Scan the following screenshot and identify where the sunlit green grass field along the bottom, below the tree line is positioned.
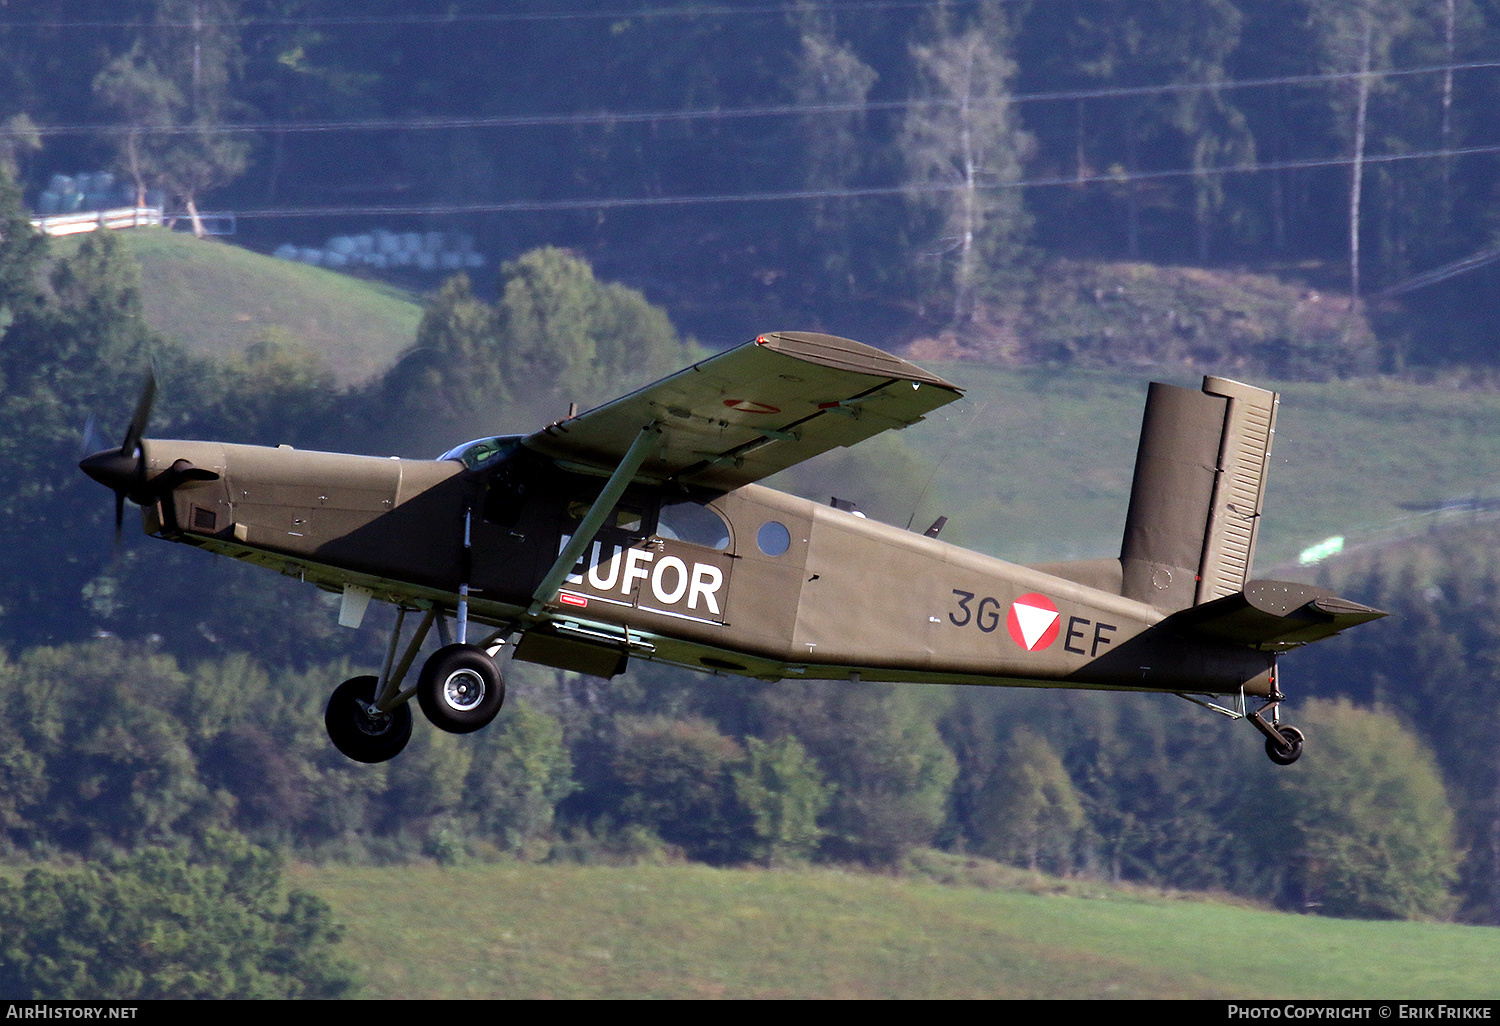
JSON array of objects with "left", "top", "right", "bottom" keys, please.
[{"left": 291, "top": 864, "right": 1500, "bottom": 999}]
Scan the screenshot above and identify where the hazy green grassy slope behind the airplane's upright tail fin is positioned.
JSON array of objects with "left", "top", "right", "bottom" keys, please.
[{"left": 780, "top": 360, "right": 1500, "bottom": 578}]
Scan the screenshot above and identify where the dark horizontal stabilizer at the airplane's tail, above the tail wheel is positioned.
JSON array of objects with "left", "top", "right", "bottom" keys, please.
[{"left": 1163, "top": 581, "right": 1386, "bottom": 651}]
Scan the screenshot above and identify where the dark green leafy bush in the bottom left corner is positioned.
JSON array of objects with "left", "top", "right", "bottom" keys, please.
[{"left": 0, "top": 834, "right": 356, "bottom": 1001}]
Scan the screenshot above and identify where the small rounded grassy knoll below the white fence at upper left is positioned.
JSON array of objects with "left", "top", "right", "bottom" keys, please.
[{"left": 53, "top": 228, "right": 422, "bottom": 384}]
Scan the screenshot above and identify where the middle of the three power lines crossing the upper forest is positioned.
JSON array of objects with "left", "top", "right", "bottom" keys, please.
[{"left": 20, "top": 60, "right": 1500, "bottom": 138}]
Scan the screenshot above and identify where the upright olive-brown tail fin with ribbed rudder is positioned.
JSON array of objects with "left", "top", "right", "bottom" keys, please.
[{"left": 1121, "top": 378, "right": 1278, "bottom": 611}]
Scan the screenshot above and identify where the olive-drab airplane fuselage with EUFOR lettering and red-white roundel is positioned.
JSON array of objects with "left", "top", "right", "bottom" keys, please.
[{"left": 144, "top": 440, "right": 1272, "bottom": 695}]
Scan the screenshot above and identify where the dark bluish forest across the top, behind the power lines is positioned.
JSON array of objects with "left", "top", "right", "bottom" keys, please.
[{"left": 0, "top": 0, "right": 1500, "bottom": 360}]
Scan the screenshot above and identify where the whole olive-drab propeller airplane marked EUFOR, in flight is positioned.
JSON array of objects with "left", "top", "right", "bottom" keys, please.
[{"left": 81, "top": 332, "right": 1383, "bottom": 764}]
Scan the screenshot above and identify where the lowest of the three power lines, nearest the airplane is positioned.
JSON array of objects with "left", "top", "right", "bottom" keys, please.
[{"left": 219, "top": 146, "right": 1500, "bottom": 221}]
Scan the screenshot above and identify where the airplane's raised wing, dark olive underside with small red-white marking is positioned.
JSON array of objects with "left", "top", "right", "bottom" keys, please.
[{"left": 524, "top": 332, "right": 963, "bottom": 491}]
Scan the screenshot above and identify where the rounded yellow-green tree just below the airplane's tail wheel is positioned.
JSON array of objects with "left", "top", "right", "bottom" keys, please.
[{"left": 1277, "top": 699, "right": 1460, "bottom": 920}]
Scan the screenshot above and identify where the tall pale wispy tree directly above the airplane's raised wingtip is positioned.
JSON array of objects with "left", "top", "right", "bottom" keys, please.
[{"left": 897, "top": 3, "right": 1031, "bottom": 324}]
